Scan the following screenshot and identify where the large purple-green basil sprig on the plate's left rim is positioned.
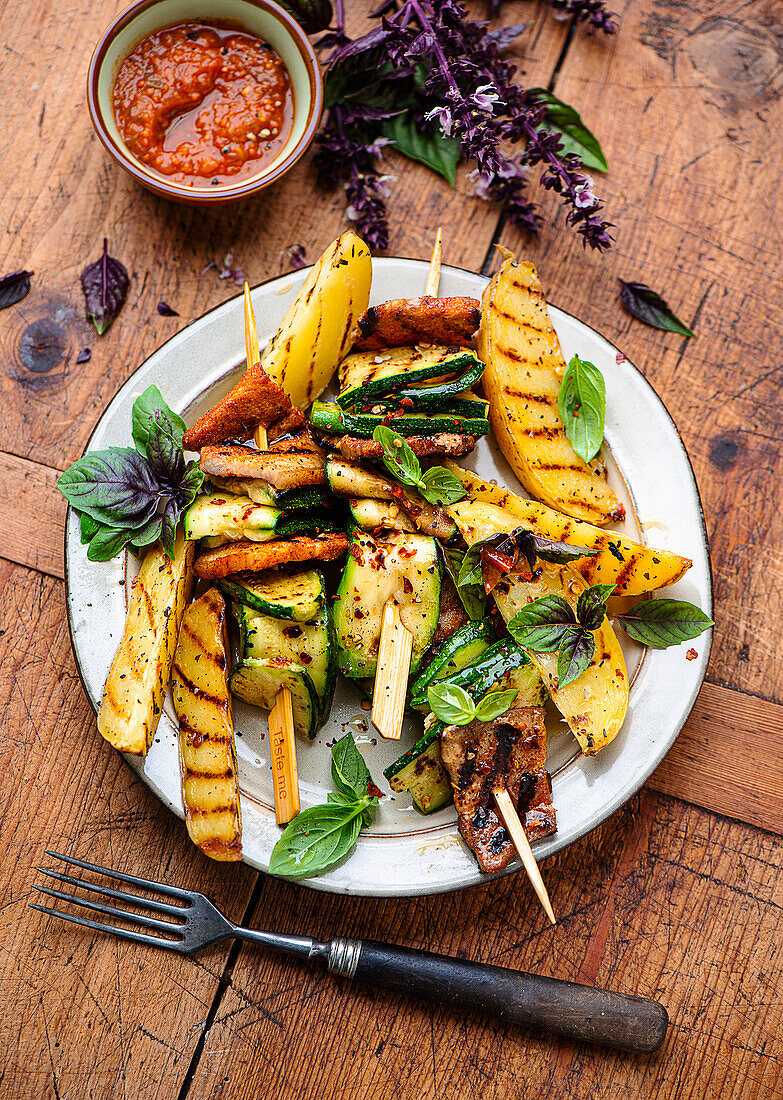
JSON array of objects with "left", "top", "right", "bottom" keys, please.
[{"left": 57, "top": 386, "right": 203, "bottom": 561}]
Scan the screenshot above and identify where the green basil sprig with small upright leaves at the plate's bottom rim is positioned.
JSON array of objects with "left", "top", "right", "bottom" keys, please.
[{"left": 269, "top": 734, "right": 378, "bottom": 878}]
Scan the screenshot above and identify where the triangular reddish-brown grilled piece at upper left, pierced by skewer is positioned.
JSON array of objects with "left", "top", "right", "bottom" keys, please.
[{"left": 183, "top": 363, "right": 304, "bottom": 451}]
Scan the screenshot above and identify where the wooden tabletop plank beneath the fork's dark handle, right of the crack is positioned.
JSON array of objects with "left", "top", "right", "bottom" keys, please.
[{"left": 188, "top": 793, "right": 783, "bottom": 1100}]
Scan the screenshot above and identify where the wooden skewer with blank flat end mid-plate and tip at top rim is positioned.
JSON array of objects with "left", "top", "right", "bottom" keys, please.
[{"left": 371, "top": 228, "right": 443, "bottom": 740}]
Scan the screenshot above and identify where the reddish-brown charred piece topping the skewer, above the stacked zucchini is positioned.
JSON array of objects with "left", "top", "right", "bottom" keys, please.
[{"left": 352, "top": 298, "right": 482, "bottom": 351}]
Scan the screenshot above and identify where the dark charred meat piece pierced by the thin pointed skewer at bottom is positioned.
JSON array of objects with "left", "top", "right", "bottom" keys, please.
[{"left": 440, "top": 706, "right": 556, "bottom": 873}]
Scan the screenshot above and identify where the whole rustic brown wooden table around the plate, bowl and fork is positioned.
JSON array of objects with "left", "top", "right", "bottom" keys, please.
[{"left": 0, "top": 0, "right": 783, "bottom": 1100}]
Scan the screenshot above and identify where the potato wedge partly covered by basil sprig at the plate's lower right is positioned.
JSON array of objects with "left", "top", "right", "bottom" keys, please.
[{"left": 493, "top": 562, "right": 628, "bottom": 756}]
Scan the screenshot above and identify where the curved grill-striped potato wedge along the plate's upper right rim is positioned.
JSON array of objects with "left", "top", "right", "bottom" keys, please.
[{"left": 478, "top": 254, "right": 622, "bottom": 527}]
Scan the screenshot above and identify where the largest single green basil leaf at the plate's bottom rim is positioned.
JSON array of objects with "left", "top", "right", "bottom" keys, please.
[{"left": 269, "top": 801, "right": 367, "bottom": 878}]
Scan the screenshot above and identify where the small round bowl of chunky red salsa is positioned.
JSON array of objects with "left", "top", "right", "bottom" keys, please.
[{"left": 88, "top": 0, "right": 322, "bottom": 204}]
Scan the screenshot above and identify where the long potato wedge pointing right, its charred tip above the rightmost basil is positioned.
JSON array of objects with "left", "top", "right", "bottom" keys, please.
[{"left": 443, "top": 470, "right": 692, "bottom": 596}]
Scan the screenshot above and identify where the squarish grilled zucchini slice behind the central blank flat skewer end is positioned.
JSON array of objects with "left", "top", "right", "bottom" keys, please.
[{"left": 332, "top": 529, "right": 441, "bottom": 679}]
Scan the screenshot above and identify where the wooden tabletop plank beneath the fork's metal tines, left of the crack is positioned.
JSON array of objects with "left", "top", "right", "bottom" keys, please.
[{"left": 0, "top": 562, "right": 256, "bottom": 1100}]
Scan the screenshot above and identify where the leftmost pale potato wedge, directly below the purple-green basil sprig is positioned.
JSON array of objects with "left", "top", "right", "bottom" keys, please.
[{"left": 98, "top": 531, "right": 196, "bottom": 756}]
